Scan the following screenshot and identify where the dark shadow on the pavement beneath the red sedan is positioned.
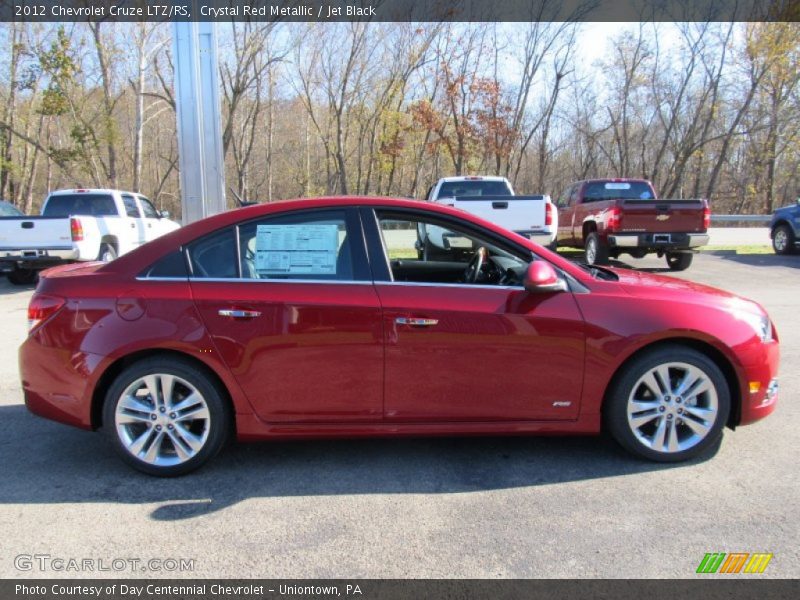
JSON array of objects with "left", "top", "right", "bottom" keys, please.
[{"left": 0, "top": 405, "right": 718, "bottom": 521}]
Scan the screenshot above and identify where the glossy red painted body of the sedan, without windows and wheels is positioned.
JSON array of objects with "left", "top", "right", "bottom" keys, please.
[{"left": 20, "top": 198, "right": 778, "bottom": 440}]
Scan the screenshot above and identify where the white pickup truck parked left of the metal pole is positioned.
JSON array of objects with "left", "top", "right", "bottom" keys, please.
[{"left": 0, "top": 189, "right": 180, "bottom": 285}]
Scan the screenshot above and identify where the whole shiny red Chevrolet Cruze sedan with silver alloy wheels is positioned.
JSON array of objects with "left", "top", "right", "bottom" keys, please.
[{"left": 20, "top": 198, "right": 778, "bottom": 475}]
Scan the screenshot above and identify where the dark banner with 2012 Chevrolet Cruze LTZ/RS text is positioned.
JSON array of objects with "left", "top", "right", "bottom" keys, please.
[{"left": 0, "top": 0, "right": 800, "bottom": 22}]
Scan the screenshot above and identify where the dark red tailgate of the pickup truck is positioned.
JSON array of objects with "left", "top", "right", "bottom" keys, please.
[{"left": 618, "top": 200, "right": 705, "bottom": 233}]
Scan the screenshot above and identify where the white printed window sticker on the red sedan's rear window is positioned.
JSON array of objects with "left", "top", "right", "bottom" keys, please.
[{"left": 256, "top": 224, "right": 339, "bottom": 276}]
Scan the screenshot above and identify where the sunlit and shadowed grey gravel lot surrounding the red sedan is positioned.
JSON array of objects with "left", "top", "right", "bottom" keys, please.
[{"left": 0, "top": 251, "right": 800, "bottom": 578}]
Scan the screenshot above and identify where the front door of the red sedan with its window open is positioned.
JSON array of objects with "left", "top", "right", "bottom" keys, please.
[{"left": 376, "top": 211, "right": 584, "bottom": 422}]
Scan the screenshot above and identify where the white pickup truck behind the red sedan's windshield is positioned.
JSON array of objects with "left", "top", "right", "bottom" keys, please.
[{"left": 418, "top": 176, "right": 558, "bottom": 257}]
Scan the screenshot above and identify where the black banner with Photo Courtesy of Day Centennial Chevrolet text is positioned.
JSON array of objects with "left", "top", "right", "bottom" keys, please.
[{"left": 0, "top": 576, "right": 800, "bottom": 600}]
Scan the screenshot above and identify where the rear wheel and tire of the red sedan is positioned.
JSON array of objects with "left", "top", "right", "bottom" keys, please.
[{"left": 103, "top": 357, "right": 232, "bottom": 477}]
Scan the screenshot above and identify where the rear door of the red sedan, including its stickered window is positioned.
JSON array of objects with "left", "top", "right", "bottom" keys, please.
[{"left": 188, "top": 209, "right": 383, "bottom": 423}]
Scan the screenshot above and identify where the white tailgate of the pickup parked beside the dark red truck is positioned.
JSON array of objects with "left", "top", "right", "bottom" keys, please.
[{"left": 444, "top": 196, "right": 547, "bottom": 231}]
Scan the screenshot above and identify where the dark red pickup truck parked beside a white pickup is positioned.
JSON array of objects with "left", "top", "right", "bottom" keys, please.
[{"left": 556, "top": 179, "right": 711, "bottom": 271}]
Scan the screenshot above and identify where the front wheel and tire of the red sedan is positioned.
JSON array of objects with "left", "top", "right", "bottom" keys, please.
[{"left": 603, "top": 345, "right": 731, "bottom": 462}]
